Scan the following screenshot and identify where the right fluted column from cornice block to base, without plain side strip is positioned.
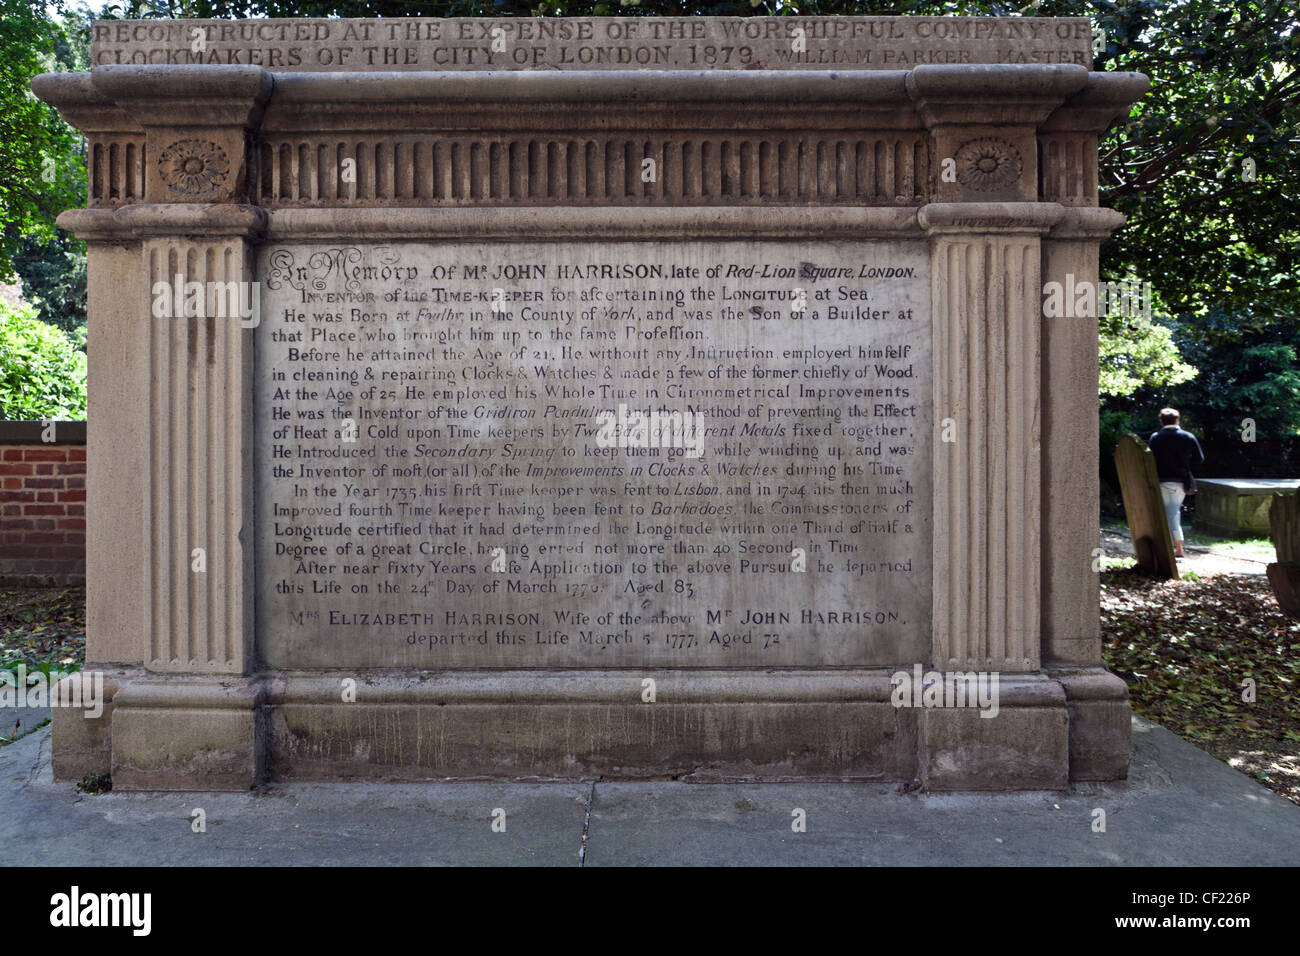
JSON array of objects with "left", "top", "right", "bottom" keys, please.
[{"left": 907, "top": 65, "right": 1089, "bottom": 788}]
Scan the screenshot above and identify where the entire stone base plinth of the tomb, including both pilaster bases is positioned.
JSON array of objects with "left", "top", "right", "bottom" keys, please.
[{"left": 53, "top": 669, "right": 1130, "bottom": 791}]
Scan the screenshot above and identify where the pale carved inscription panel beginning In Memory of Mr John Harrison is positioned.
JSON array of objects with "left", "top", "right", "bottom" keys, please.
[{"left": 255, "top": 241, "right": 932, "bottom": 670}]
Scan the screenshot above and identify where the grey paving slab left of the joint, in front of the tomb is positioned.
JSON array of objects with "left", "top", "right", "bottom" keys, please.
[{"left": 0, "top": 728, "right": 592, "bottom": 866}]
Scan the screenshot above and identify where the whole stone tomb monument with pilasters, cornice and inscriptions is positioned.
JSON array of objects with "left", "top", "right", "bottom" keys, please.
[{"left": 34, "top": 17, "right": 1147, "bottom": 790}]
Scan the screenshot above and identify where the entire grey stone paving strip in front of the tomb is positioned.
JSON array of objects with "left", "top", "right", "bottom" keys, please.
[{"left": 0, "top": 718, "right": 1300, "bottom": 866}]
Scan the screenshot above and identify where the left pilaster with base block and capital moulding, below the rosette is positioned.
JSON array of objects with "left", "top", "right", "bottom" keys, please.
[{"left": 56, "top": 203, "right": 267, "bottom": 790}]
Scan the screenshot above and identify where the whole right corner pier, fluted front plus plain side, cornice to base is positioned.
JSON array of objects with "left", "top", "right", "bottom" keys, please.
[{"left": 907, "top": 65, "right": 1145, "bottom": 787}]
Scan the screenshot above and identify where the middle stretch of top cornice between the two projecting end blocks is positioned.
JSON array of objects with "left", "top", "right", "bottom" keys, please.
[{"left": 264, "top": 70, "right": 922, "bottom": 138}]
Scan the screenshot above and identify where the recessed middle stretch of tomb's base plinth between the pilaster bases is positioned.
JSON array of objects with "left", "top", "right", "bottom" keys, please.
[{"left": 268, "top": 671, "right": 917, "bottom": 780}]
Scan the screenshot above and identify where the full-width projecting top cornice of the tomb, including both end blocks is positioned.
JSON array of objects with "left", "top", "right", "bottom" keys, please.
[{"left": 33, "top": 64, "right": 1148, "bottom": 133}]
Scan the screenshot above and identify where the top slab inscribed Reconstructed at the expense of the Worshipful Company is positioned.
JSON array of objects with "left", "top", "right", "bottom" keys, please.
[{"left": 91, "top": 17, "right": 1092, "bottom": 72}]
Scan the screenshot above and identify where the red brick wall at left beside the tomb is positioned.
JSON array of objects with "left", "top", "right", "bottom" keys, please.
[{"left": 0, "top": 421, "right": 86, "bottom": 585}]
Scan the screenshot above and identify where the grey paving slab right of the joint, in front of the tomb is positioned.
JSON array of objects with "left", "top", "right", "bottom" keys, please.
[{"left": 586, "top": 718, "right": 1300, "bottom": 866}]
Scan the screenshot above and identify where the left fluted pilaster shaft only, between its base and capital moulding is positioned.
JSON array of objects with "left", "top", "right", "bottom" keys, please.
[{"left": 143, "top": 238, "right": 254, "bottom": 674}]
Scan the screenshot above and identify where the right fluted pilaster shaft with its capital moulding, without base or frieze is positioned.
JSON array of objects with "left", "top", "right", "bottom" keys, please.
[{"left": 919, "top": 203, "right": 1061, "bottom": 671}]
